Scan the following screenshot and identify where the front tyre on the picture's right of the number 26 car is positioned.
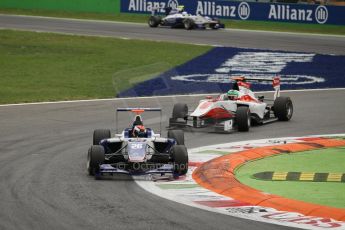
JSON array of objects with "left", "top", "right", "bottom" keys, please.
[{"left": 171, "top": 145, "right": 188, "bottom": 175}]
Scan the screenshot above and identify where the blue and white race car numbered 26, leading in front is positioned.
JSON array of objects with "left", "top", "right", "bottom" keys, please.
[{"left": 87, "top": 108, "right": 188, "bottom": 179}]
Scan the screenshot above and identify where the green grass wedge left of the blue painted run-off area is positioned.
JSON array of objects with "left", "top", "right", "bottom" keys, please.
[{"left": 0, "top": 30, "right": 211, "bottom": 104}]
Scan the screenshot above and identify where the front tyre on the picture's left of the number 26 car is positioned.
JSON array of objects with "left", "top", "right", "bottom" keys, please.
[{"left": 87, "top": 145, "right": 105, "bottom": 175}]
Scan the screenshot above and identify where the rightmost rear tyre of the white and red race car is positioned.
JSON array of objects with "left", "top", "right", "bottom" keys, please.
[{"left": 273, "top": 97, "right": 293, "bottom": 121}]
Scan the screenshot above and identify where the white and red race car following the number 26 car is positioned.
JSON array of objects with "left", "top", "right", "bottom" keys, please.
[{"left": 169, "top": 77, "right": 293, "bottom": 132}]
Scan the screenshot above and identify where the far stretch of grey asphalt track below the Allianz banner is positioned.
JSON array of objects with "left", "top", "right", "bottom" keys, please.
[{"left": 0, "top": 14, "right": 345, "bottom": 54}]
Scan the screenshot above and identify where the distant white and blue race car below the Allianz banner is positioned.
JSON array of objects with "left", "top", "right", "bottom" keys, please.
[{"left": 148, "top": 6, "right": 225, "bottom": 30}]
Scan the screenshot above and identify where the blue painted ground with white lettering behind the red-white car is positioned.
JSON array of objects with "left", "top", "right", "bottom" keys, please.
[{"left": 118, "top": 47, "right": 345, "bottom": 97}]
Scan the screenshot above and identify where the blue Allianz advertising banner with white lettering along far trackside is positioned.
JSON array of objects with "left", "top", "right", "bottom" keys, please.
[{"left": 121, "top": 0, "right": 345, "bottom": 25}]
